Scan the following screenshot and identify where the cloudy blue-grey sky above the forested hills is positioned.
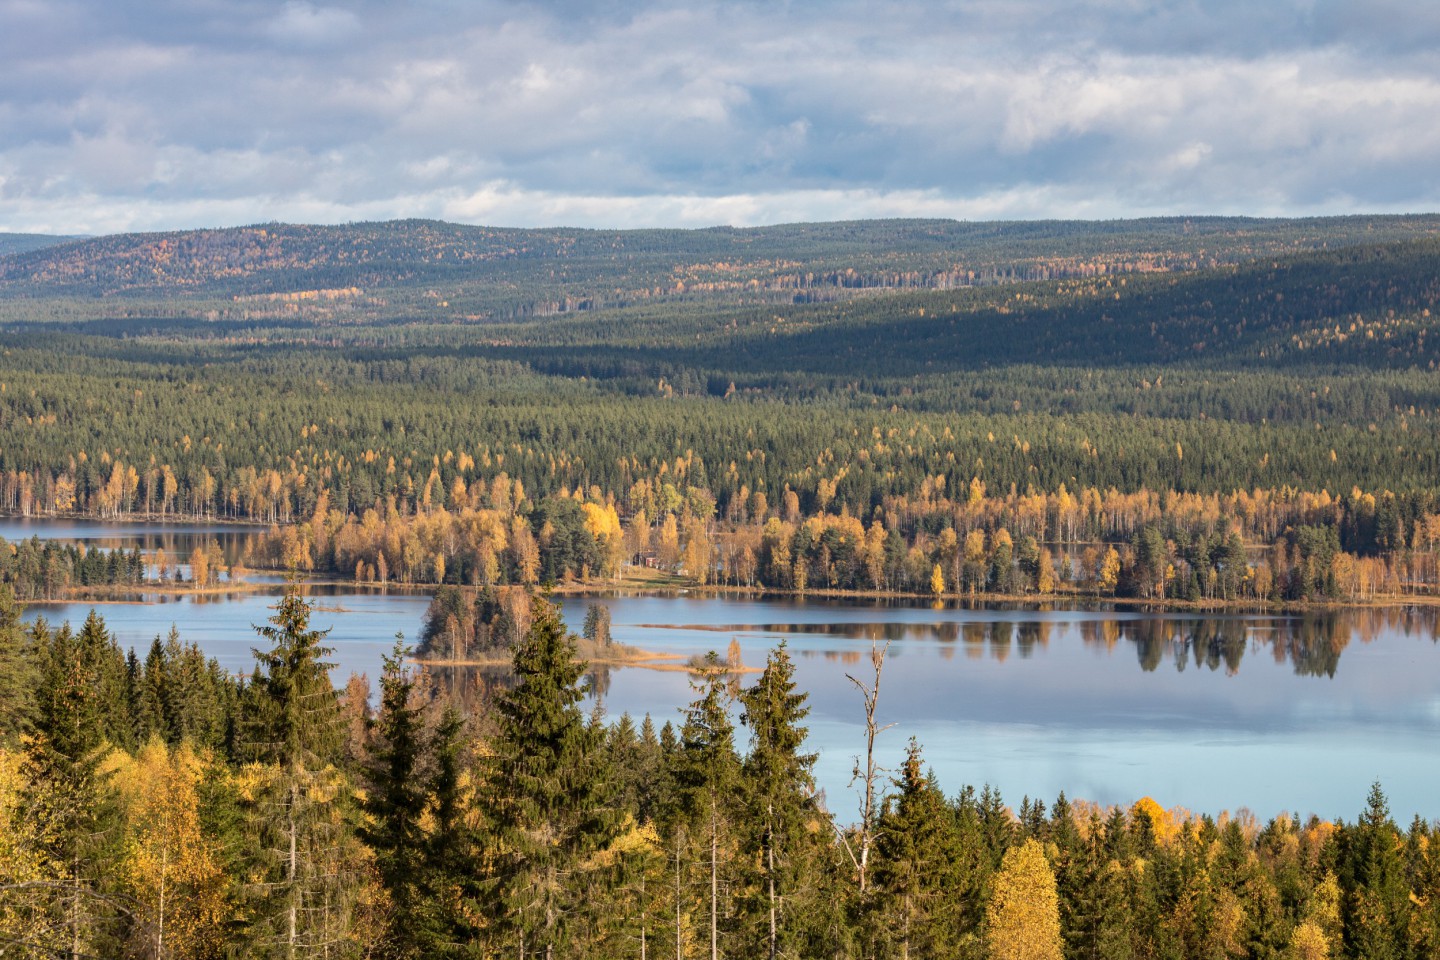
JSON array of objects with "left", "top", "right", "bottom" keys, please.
[{"left": 0, "top": 0, "right": 1440, "bottom": 235}]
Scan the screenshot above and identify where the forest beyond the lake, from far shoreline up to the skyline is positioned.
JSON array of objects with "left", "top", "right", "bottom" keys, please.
[{"left": 0, "top": 217, "right": 1440, "bottom": 602}]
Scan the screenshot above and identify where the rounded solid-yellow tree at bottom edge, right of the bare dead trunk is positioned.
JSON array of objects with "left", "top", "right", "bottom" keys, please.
[{"left": 985, "top": 841, "right": 1061, "bottom": 960}]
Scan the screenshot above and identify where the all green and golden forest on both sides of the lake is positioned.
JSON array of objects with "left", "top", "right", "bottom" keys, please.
[{"left": 0, "top": 217, "right": 1440, "bottom": 960}]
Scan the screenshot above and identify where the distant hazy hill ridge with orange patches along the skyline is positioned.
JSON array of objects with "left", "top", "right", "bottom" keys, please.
[{"left": 8, "top": 216, "right": 1440, "bottom": 303}]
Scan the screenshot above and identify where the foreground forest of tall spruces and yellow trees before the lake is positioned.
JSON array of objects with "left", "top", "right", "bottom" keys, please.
[{"left": 0, "top": 589, "right": 1440, "bottom": 960}]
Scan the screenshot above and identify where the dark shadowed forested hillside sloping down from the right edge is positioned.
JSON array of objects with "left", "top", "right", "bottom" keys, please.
[{"left": 457, "top": 239, "right": 1440, "bottom": 386}]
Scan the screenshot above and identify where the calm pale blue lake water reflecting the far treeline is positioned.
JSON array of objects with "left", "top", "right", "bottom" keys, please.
[{"left": 11, "top": 522, "right": 1440, "bottom": 820}]
